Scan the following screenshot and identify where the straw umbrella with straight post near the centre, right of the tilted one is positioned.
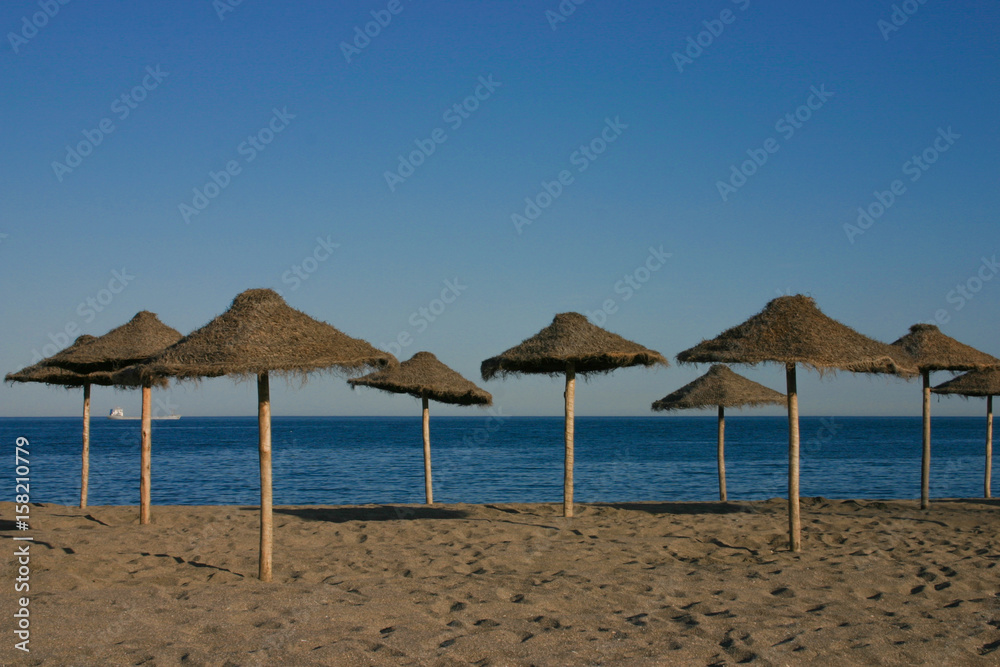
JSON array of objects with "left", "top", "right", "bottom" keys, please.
[{"left": 480, "top": 313, "right": 669, "bottom": 517}]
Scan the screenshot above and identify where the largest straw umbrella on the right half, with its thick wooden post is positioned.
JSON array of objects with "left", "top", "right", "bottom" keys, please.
[{"left": 677, "top": 294, "right": 914, "bottom": 551}]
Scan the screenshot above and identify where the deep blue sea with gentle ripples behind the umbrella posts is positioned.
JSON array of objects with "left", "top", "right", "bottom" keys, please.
[{"left": 0, "top": 413, "right": 1000, "bottom": 505}]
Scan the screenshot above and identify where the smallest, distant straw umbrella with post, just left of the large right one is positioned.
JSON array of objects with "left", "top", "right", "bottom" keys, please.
[{"left": 652, "top": 364, "right": 785, "bottom": 502}]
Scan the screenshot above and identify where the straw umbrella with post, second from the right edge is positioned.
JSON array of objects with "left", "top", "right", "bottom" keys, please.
[{"left": 893, "top": 324, "right": 1000, "bottom": 509}]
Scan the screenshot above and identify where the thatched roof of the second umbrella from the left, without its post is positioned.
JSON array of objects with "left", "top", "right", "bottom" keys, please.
[{"left": 44, "top": 310, "right": 181, "bottom": 373}]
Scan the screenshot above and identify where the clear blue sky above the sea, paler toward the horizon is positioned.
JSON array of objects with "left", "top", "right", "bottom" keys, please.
[{"left": 0, "top": 0, "right": 1000, "bottom": 416}]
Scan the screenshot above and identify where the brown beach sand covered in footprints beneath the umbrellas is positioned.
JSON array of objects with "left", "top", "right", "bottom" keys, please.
[{"left": 0, "top": 498, "right": 1000, "bottom": 665}]
